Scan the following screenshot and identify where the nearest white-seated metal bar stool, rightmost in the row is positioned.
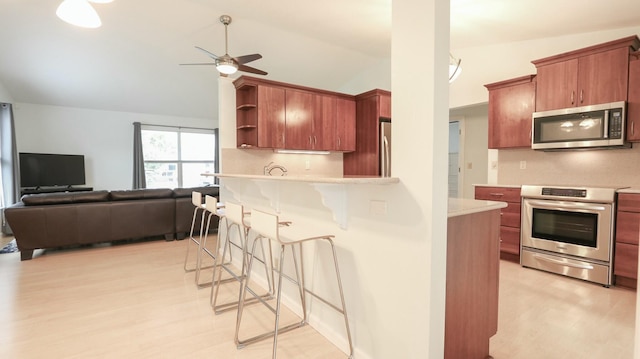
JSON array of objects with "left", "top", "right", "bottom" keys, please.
[{"left": 235, "top": 210, "right": 353, "bottom": 359}]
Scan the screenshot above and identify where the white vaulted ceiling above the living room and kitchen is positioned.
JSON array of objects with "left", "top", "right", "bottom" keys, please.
[{"left": 0, "top": 0, "right": 640, "bottom": 118}]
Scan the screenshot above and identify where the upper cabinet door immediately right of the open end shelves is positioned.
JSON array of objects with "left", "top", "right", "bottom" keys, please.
[{"left": 258, "top": 85, "right": 285, "bottom": 148}]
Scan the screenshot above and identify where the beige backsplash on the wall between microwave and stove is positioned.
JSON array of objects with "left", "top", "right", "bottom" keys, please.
[{"left": 498, "top": 144, "right": 640, "bottom": 187}]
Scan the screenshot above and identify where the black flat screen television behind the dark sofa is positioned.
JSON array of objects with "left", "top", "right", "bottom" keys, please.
[{"left": 19, "top": 152, "right": 85, "bottom": 187}]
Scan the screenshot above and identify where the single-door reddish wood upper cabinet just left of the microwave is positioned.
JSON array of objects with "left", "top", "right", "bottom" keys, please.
[{"left": 485, "top": 75, "right": 536, "bottom": 149}]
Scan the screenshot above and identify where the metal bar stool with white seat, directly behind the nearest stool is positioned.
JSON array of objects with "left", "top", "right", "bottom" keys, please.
[{"left": 207, "top": 202, "right": 273, "bottom": 314}]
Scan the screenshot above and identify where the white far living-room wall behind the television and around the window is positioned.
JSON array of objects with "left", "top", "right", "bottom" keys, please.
[{"left": 13, "top": 103, "right": 217, "bottom": 190}]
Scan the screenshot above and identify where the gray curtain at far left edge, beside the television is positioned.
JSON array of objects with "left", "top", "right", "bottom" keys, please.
[{"left": 0, "top": 103, "right": 20, "bottom": 234}]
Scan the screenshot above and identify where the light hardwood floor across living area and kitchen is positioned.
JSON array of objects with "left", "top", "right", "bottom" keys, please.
[{"left": 0, "top": 240, "right": 635, "bottom": 359}]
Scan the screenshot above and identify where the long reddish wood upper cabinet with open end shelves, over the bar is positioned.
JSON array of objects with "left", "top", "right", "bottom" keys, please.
[{"left": 234, "top": 76, "right": 356, "bottom": 152}]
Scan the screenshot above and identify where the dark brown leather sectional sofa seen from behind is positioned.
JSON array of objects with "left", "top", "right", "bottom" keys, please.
[{"left": 4, "top": 186, "right": 219, "bottom": 260}]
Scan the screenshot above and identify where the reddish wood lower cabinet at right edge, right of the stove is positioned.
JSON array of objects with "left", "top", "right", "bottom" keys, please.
[{"left": 613, "top": 193, "right": 640, "bottom": 288}]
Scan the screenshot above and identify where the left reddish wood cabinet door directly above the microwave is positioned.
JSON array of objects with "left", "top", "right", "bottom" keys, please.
[{"left": 536, "top": 59, "right": 578, "bottom": 111}]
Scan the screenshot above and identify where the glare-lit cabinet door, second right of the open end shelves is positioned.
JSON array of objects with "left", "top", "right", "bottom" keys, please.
[{"left": 285, "top": 89, "right": 314, "bottom": 150}]
